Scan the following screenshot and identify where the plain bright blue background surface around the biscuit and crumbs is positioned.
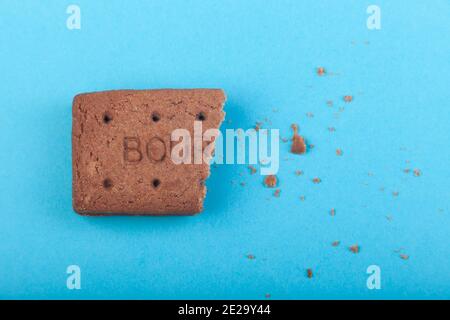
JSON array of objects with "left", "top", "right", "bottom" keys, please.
[{"left": 0, "top": 0, "right": 450, "bottom": 299}]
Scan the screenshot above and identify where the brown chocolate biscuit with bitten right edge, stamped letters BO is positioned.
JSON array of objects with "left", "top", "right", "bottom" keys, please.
[{"left": 72, "top": 89, "right": 225, "bottom": 215}]
